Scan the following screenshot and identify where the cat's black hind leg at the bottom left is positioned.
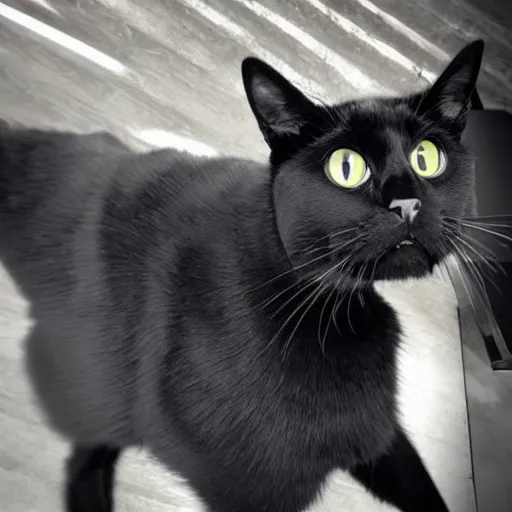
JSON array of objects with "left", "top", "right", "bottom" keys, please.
[{"left": 64, "top": 445, "right": 121, "bottom": 512}]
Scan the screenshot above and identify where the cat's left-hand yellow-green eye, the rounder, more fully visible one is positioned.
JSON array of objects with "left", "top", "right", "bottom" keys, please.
[{"left": 326, "top": 149, "right": 370, "bottom": 188}]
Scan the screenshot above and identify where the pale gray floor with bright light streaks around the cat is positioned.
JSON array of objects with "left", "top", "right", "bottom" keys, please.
[{"left": 0, "top": 0, "right": 512, "bottom": 512}]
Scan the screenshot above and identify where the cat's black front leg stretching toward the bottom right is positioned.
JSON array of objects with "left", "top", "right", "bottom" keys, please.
[{"left": 350, "top": 430, "right": 449, "bottom": 512}]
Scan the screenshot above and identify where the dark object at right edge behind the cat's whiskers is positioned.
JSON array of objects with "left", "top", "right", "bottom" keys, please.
[{"left": 459, "top": 110, "right": 512, "bottom": 371}]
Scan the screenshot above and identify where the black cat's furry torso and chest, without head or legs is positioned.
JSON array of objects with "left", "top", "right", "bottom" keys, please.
[{"left": 0, "top": 125, "right": 398, "bottom": 510}]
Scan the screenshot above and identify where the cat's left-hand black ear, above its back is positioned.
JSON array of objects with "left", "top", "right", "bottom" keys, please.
[{"left": 242, "top": 57, "right": 317, "bottom": 149}]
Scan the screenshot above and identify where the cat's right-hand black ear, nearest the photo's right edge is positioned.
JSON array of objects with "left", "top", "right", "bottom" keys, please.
[{"left": 419, "top": 40, "right": 484, "bottom": 131}]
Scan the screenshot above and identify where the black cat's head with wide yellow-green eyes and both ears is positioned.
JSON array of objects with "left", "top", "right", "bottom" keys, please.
[{"left": 242, "top": 41, "right": 484, "bottom": 283}]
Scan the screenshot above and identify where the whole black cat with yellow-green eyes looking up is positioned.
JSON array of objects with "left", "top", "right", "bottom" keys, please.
[{"left": 0, "top": 41, "right": 483, "bottom": 512}]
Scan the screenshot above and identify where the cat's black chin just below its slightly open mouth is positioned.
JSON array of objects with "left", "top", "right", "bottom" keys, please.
[{"left": 374, "top": 245, "right": 435, "bottom": 281}]
